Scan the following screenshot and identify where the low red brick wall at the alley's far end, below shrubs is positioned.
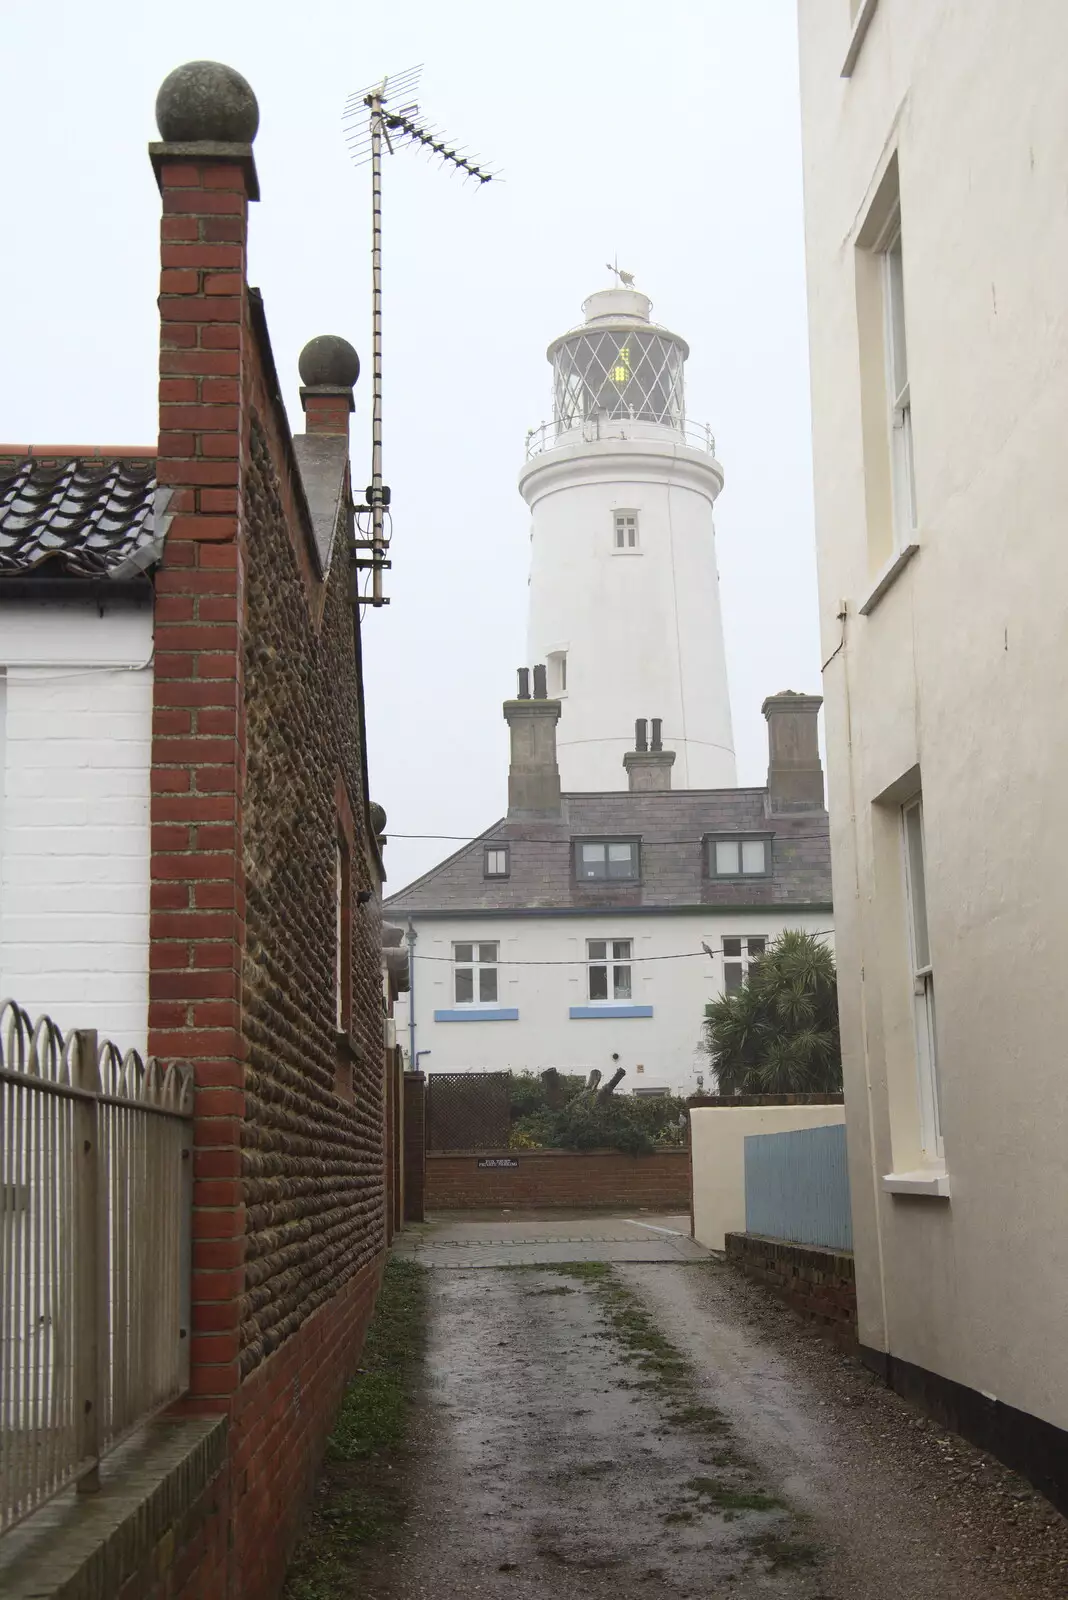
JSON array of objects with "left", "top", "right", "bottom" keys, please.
[{"left": 427, "top": 1150, "right": 689, "bottom": 1211}]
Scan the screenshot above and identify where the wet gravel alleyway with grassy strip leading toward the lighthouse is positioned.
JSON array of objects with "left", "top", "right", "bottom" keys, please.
[{"left": 321, "top": 1218, "right": 1068, "bottom": 1600}]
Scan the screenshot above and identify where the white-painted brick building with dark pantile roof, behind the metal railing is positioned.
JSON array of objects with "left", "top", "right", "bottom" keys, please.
[{"left": 0, "top": 450, "right": 166, "bottom": 1051}]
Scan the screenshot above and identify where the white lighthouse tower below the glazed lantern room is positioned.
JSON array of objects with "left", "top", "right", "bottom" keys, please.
[{"left": 523, "top": 440, "right": 737, "bottom": 790}]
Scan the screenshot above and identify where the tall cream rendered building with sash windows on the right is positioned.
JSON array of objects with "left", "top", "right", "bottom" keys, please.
[{"left": 799, "top": 0, "right": 1068, "bottom": 1507}]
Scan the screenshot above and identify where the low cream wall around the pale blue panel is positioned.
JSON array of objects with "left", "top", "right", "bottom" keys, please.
[{"left": 689, "top": 1106, "right": 846, "bottom": 1250}]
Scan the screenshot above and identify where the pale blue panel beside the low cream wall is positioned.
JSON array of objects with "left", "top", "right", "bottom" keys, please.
[{"left": 745, "top": 1123, "right": 852, "bottom": 1250}]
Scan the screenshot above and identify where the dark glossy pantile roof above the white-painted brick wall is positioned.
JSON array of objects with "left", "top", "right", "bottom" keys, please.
[{"left": 0, "top": 451, "right": 158, "bottom": 579}]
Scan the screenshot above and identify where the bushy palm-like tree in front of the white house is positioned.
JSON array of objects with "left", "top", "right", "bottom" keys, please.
[{"left": 703, "top": 928, "right": 843, "bottom": 1094}]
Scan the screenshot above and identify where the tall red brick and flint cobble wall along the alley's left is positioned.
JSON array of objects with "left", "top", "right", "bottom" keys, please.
[{"left": 143, "top": 118, "right": 385, "bottom": 1600}]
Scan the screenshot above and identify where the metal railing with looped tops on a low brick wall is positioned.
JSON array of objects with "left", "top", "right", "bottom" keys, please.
[{"left": 0, "top": 1000, "right": 193, "bottom": 1533}]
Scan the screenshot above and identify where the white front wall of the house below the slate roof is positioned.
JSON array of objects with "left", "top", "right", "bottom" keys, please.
[{"left": 397, "top": 907, "right": 830, "bottom": 1094}]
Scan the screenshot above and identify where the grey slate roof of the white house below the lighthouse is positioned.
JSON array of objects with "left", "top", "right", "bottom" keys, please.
[{"left": 384, "top": 789, "right": 831, "bottom": 917}]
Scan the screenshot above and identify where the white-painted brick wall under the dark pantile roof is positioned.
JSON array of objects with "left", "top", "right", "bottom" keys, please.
[{"left": 0, "top": 602, "right": 152, "bottom": 1050}]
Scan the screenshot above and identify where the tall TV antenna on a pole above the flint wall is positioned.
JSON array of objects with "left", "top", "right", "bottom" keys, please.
[{"left": 344, "top": 66, "right": 497, "bottom": 606}]
